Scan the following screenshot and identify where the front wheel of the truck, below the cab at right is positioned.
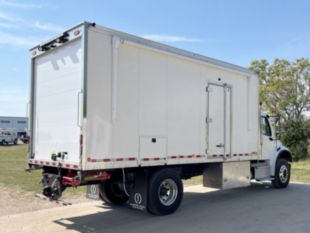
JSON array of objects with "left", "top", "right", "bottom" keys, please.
[{"left": 272, "top": 159, "right": 291, "bottom": 188}]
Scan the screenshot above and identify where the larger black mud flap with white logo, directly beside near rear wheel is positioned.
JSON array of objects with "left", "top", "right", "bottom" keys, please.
[{"left": 128, "top": 171, "right": 148, "bottom": 211}]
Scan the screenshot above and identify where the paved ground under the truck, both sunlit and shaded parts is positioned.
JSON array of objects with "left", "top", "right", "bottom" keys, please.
[{"left": 0, "top": 184, "right": 310, "bottom": 233}]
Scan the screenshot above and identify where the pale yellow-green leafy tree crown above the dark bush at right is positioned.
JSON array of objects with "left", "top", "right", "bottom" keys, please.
[{"left": 250, "top": 58, "right": 310, "bottom": 120}]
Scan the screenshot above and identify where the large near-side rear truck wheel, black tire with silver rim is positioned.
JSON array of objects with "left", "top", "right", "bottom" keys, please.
[{"left": 147, "top": 169, "right": 183, "bottom": 215}]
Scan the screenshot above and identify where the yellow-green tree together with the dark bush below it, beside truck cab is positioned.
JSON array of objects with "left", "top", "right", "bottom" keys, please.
[{"left": 250, "top": 58, "right": 310, "bottom": 160}]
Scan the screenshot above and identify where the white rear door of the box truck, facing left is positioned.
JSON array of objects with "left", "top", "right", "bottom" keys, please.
[{"left": 32, "top": 37, "right": 83, "bottom": 164}]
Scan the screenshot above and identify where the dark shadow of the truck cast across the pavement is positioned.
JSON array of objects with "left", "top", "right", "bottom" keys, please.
[{"left": 55, "top": 184, "right": 310, "bottom": 233}]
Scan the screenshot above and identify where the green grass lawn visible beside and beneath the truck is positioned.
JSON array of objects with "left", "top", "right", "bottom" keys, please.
[{"left": 0, "top": 145, "right": 310, "bottom": 195}]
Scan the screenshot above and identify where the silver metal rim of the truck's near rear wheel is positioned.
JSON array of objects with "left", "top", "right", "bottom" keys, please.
[{"left": 158, "top": 179, "right": 178, "bottom": 206}]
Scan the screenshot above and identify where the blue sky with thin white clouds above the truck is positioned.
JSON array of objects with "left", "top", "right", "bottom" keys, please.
[{"left": 0, "top": 0, "right": 310, "bottom": 116}]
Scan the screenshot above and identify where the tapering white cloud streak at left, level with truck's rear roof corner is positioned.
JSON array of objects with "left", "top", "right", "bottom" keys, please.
[{"left": 0, "top": 32, "right": 46, "bottom": 48}]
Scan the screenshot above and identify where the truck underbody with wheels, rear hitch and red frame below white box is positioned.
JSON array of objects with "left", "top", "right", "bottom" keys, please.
[{"left": 32, "top": 154, "right": 291, "bottom": 215}]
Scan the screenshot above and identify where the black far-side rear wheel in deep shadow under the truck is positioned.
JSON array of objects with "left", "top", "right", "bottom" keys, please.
[{"left": 99, "top": 180, "right": 129, "bottom": 205}]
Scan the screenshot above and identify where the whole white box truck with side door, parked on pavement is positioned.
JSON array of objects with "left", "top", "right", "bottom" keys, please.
[{"left": 28, "top": 22, "right": 292, "bottom": 215}]
